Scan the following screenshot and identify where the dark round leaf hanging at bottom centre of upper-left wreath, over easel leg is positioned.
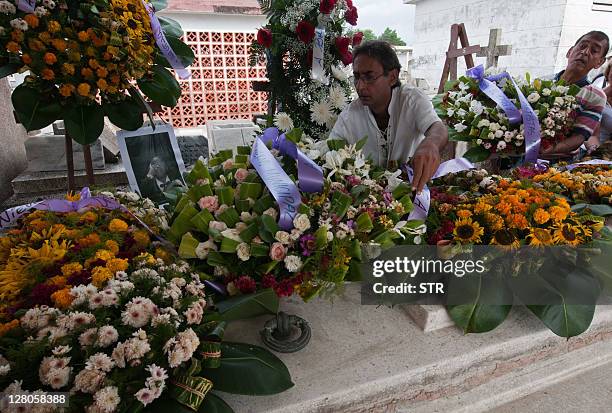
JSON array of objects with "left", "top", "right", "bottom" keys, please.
[{"left": 64, "top": 103, "right": 104, "bottom": 145}]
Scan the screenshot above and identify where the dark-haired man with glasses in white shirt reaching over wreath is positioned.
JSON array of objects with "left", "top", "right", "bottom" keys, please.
[{"left": 330, "top": 40, "right": 448, "bottom": 192}]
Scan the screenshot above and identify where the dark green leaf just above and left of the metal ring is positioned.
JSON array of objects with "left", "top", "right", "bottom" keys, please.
[{"left": 214, "top": 288, "right": 278, "bottom": 321}]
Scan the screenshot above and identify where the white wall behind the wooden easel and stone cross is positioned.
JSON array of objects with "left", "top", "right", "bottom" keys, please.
[{"left": 405, "top": 0, "right": 568, "bottom": 89}]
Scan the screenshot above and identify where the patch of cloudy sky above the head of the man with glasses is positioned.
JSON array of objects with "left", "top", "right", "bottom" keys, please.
[{"left": 353, "top": 0, "right": 415, "bottom": 46}]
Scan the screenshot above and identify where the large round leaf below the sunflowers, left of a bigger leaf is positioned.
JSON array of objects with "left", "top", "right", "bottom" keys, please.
[{"left": 447, "top": 275, "right": 512, "bottom": 333}]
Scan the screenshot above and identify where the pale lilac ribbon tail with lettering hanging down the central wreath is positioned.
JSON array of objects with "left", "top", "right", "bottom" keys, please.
[{"left": 251, "top": 138, "right": 302, "bottom": 231}]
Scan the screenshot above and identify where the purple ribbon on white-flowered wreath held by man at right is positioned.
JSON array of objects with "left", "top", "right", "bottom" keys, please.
[{"left": 466, "top": 65, "right": 541, "bottom": 163}]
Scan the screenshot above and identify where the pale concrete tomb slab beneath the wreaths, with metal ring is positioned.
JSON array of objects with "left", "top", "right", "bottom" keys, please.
[{"left": 224, "top": 285, "right": 612, "bottom": 413}]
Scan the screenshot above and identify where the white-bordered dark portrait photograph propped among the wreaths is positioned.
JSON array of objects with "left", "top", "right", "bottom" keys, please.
[{"left": 117, "top": 125, "right": 185, "bottom": 204}]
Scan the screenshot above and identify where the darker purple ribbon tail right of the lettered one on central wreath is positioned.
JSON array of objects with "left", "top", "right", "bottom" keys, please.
[{"left": 259, "top": 128, "right": 323, "bottom": 193}]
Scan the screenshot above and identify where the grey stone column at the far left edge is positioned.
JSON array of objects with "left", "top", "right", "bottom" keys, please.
[{"left": 0, "top": 78, "right": 28, "bottom": 204}]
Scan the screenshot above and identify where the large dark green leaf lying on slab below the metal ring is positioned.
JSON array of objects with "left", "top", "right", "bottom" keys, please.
[{"left": 202, "top": 343, "right": 293, "bottom": 395}]
